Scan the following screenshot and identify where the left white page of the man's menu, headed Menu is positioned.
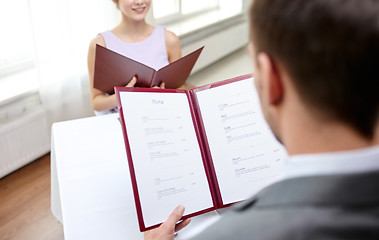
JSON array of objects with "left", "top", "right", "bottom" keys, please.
[{"left": 120, "top": 92, "right": 213, "bottom": 227}]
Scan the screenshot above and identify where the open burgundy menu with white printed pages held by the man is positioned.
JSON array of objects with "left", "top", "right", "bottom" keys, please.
[{"left": 115, "top": 75, "right": 286, "bottom": 231}]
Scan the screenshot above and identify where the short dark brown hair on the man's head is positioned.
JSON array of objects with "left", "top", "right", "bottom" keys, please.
[{"left": 250, "top": 0, "right": 379, "bottom": 138}]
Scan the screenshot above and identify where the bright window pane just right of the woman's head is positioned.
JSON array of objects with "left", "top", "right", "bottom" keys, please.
[{"left": 153, "top": 0, "right": 220, "bottom": 23}]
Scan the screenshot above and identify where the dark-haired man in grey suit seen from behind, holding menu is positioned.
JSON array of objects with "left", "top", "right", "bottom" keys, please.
[{"left": 145, "top": 0, "right": 379, "bottom": 240}]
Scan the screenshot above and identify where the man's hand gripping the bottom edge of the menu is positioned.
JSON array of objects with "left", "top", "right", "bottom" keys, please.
[{"left": 144, "top": 205, "right": 191, "bottom": 240}]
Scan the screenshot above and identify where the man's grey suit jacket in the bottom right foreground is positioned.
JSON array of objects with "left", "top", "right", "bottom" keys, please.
[{"left": 194, "top": 170, "right": 379, "bottom": 240}]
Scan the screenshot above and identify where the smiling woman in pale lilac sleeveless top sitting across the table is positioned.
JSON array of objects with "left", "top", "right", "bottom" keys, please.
[{"left": 88, "top": 0, "right": 181, "bottom": 113}]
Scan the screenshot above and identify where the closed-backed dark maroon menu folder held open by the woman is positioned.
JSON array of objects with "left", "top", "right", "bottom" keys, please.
[{"left": 94, "top": 45, "right": 204, "bottom": 94}]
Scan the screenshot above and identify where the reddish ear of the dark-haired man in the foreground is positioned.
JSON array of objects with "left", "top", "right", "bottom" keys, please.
[{"left": 257, "top": 53, "right": 284, "bottom": 105}]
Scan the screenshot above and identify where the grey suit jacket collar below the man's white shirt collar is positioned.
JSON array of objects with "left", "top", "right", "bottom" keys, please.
[{"left": 235, "top": 170, "right": 379, "bottom": 211}]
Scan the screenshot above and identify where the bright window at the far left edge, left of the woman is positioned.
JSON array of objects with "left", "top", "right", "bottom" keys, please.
[{"left": 0, "top": 0, "right": 38, "bottom": 102}]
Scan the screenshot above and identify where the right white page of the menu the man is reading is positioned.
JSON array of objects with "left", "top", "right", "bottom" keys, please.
[{"left": 196, "top": 78, "right": 286, "bottom": 204}]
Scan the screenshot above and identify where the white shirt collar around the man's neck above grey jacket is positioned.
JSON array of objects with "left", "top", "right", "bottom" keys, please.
[{"left": 283, "top": 146, "right": 379, "bottom": 179}]
